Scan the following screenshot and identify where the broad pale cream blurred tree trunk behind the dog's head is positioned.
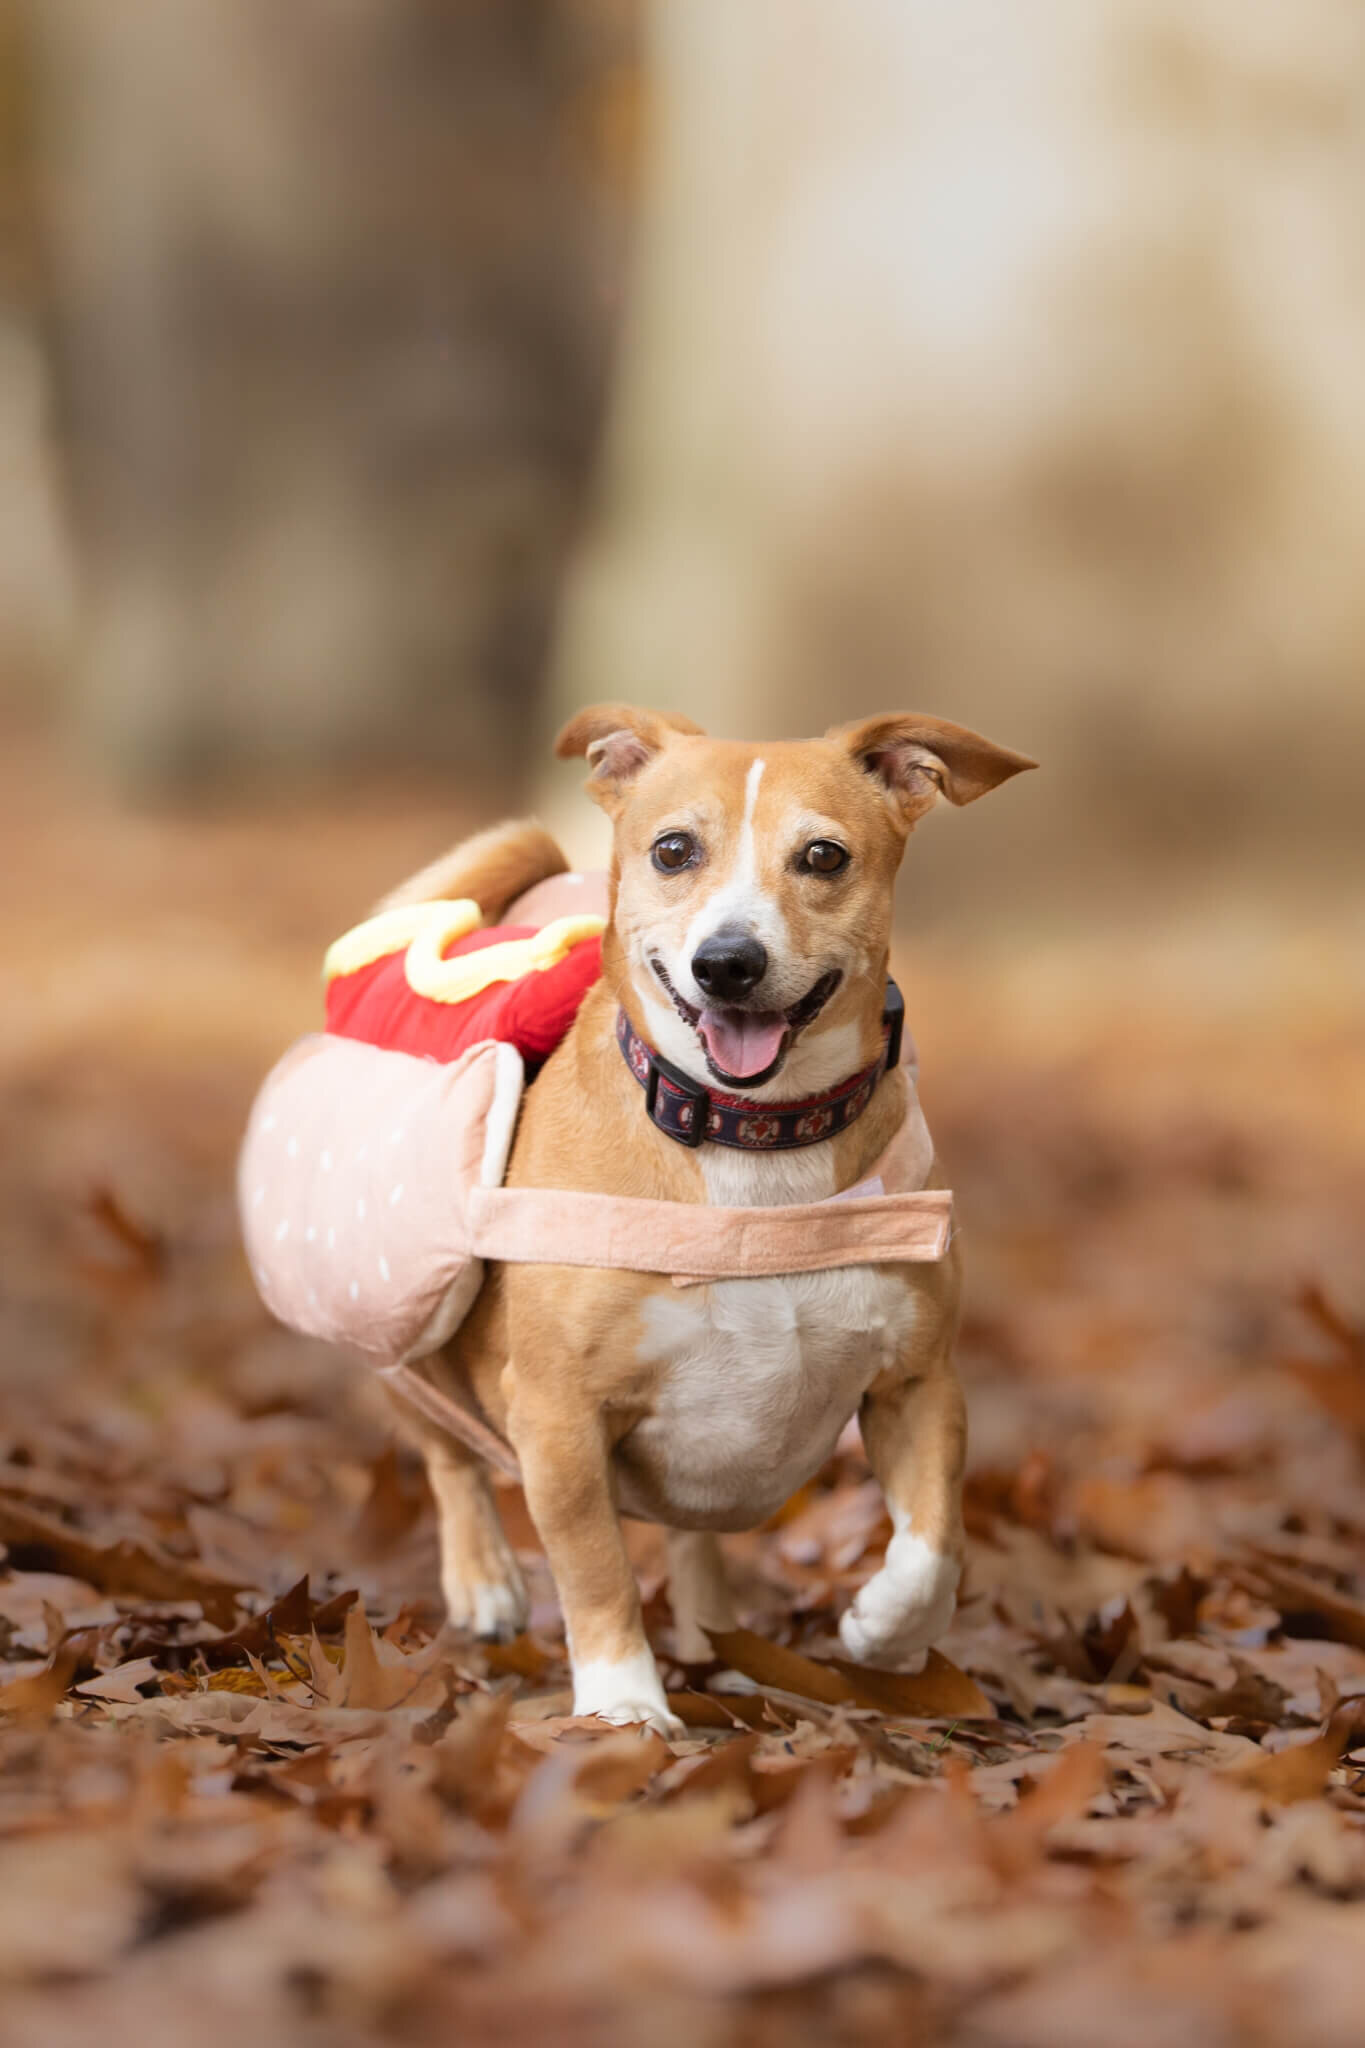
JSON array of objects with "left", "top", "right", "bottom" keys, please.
[{"left": 553, "top": 0, "right": 1365, "bottom": 909}]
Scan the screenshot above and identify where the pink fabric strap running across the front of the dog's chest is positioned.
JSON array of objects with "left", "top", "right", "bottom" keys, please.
[{"left": 467, "top": 1188, "right": 952, "bottom": 1286}]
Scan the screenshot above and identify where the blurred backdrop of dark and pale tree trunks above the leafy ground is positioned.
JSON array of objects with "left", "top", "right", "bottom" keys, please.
[{"left": 0, "top": 0, "right": 1365, "bottom": 924}]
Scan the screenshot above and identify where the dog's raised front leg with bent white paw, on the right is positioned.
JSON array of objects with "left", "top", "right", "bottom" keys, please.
[{"left": 839, "top": 1360, "right": 966, "bottom": 1671}]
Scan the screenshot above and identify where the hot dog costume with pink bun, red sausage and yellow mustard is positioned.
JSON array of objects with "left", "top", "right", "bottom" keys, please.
[{"left": 237, "top": 877, "right": 952, "bottom": 1470}]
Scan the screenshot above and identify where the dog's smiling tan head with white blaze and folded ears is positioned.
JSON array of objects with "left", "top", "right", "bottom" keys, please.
[{"left": 555, "top": 705, "right": 1036, "bottom": 1096}]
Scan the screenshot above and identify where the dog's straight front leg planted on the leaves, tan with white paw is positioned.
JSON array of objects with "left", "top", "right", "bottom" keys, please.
[{"left": 503, "top": 1368, "right": 681, "bottom": 1735}]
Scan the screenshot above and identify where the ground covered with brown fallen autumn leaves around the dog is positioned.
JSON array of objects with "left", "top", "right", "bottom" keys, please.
[{"left": 0, "top": 748, "right": 1365, "bottom": 2048}]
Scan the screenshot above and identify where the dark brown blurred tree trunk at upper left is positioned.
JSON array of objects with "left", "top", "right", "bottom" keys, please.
[{"left": 27, "top": 0, "right": 630, "bottom": 795}]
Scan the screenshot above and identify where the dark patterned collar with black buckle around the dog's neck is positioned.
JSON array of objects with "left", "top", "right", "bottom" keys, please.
[{"left": 616, "top": 981, "right": 905, "bottom": 1151}]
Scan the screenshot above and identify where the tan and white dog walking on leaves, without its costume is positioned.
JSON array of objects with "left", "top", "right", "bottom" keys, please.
[{"left": 389, "top": 705, "right": 1033, "bottom": 1733}]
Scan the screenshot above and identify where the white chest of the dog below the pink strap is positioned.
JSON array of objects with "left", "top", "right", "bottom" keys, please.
[{"left": 620, "top": 1146, "right": 915, "bottom": 1528}]
